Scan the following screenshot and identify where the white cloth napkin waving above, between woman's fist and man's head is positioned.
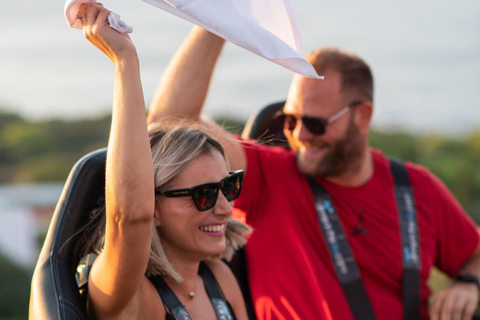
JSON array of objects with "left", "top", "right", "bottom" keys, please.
[{"left": 143, "top": 0, "right": 323, "bottom": 79}]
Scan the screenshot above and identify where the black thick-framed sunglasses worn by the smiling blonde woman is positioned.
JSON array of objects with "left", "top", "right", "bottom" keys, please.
[{"left": 155, "top": 170, "right": 243, "bottom": 211}]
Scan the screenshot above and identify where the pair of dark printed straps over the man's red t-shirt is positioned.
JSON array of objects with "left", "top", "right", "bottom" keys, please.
[{"left": 307, "top": 159, "right": 420, "bottom": 320}]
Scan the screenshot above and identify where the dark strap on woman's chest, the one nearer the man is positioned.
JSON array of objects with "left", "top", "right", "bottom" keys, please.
[{"left": 198, "top": 261, "right": 236, "bottom": 320}]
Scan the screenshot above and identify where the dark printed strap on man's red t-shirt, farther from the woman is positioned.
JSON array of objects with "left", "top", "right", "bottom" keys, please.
[{"left": 389, "top": 158, "right": 420, "bottom": 320}]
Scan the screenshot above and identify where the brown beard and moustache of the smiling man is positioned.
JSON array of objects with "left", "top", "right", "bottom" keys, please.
[{"left": 296, "top": 119, "right": 365, "bottom": 178}]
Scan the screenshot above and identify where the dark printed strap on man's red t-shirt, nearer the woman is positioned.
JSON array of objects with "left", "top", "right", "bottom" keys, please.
[{"left": 307, "top": 177, "right": 375, "bottom": 320}]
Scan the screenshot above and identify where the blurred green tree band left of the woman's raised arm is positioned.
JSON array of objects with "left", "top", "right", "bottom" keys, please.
[{"left": 0, "top": 113, "right": 110, "bottom": 183}]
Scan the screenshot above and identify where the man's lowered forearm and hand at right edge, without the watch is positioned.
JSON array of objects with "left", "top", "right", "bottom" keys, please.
[{"left": 431, "top": 239, "right": 480, "bottom": 320}]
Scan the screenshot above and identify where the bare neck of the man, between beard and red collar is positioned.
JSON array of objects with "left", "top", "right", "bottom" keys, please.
[{"left": 325, "top": 148, "right": 374, "bottom": 187}]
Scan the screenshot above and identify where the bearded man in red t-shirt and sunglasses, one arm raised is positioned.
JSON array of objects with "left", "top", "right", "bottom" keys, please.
[{"left": 149, "top": 28, "right": 480, "bottom": 320}]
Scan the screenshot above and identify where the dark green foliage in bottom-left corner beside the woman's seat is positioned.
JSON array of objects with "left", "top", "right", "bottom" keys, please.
[{"left": 0, "top": 255, "right": 31, "bottom": 320}]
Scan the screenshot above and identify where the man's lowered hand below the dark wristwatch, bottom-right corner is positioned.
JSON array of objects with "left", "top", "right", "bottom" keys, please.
[{"left": 430, "top": 281, "right": 480, "bottom": 320}]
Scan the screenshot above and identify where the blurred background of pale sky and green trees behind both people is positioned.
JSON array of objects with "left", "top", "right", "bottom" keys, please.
[{"left": 0, "top": 0, "right": 480, "bottom": 320}]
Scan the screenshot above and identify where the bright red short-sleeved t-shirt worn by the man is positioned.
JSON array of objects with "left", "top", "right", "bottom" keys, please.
[{"left": 234, "top": 144, "right": 479, "bottom": 320}]
